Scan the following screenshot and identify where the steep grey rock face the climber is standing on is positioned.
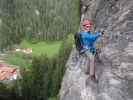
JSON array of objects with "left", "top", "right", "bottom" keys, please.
[{"left": 60, "top": 0, "right": 133, "bottom": 100}]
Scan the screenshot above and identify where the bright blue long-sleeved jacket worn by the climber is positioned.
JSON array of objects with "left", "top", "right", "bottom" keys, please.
[{"left": 80, "top": 32, "right": 101, "bottom": 52}]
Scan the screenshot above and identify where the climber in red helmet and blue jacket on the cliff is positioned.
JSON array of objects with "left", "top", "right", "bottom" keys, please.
[{"left": 80, "top": 19, "right": 104, "bottom": 81}]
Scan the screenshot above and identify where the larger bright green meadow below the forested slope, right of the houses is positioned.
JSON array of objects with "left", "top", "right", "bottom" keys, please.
[{"left": 20, "top": 40, "right": 62, "bottom": 57}]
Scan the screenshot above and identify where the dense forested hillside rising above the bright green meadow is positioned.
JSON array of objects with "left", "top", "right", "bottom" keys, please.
[{"left": 0, "top": 0, "right": 80, "bottom": 48}]
